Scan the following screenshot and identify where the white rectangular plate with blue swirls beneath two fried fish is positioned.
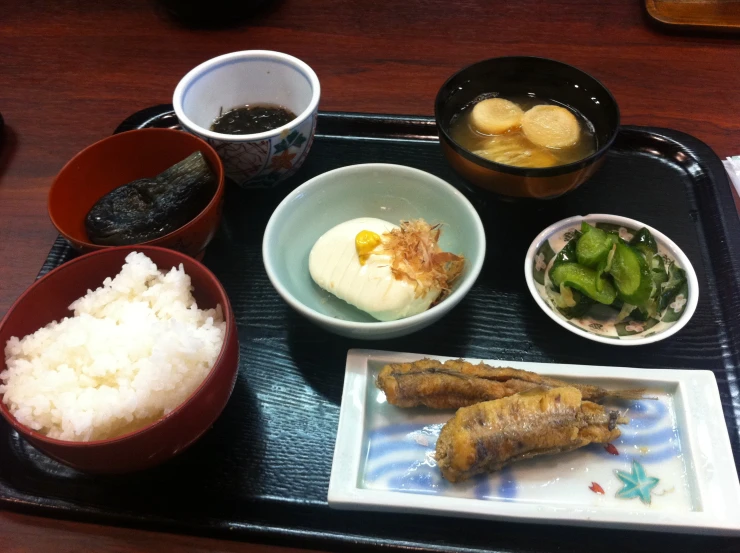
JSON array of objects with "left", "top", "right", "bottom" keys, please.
[{"left": 328, "top": 350, "right": 740, "bottom": 534}]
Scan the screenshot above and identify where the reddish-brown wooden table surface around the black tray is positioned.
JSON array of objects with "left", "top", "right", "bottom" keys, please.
[{"left": 0, "top": 0, "right": 740, "bottom": 553}]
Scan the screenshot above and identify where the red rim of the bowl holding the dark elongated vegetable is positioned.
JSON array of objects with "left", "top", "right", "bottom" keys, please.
[{"left": 46, "top": 128, "right": 226, "bottom": 251}]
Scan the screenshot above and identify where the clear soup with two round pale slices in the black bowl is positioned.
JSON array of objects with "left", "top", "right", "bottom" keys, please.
[{"left": 450, "top": 95, "right": 596, "bottom": 167}]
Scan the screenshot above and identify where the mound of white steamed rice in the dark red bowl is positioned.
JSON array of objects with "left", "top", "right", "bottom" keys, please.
[{"left": 0, "top": 252, "right": 226, "bottom": 441}]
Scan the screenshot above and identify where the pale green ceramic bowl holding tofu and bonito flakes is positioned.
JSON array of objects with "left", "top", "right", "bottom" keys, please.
[{"left": 262, "top": 163, "right": 486, "bottom": 340}]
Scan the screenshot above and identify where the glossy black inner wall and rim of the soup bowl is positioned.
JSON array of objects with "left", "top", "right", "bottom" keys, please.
[{"left": 434, "top": 56, "right": 619, "bottom": 177}]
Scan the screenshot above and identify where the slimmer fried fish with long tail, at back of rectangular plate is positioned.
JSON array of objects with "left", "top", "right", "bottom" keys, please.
[{"left": 375, "top": 359, "right": 645, "bottom": 409}]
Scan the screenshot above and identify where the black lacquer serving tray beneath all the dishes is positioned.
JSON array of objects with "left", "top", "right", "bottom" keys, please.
[{"left": 0, "top": 105, "right": 740, "bottom": 553}]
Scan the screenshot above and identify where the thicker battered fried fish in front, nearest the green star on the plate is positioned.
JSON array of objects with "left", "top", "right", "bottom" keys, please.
[{"left": 436, "top": 386, "right": 628, "bottom": 482}]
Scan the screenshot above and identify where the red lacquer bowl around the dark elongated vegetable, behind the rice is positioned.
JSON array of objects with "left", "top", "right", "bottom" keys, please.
[{"left": 48, "top": 129, "right": 224, "bottom": 257}]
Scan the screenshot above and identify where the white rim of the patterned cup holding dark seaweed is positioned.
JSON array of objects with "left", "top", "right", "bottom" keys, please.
[{"left": 172, "top": 50, "right": 321, "bottom": 142}]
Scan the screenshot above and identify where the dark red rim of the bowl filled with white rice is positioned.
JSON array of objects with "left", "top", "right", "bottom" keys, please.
[{"left": 0, "top": 244, "right": 236, "bottom": 449}]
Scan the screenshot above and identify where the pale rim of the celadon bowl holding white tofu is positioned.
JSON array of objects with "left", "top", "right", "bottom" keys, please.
[{"left": 262, "top": 163, "right": 486, "bottom": 333}]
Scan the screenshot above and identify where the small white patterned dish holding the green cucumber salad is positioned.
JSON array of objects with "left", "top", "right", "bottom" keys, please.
[{"left": 524, "top": 214, "right": 699, "bottom": 346}]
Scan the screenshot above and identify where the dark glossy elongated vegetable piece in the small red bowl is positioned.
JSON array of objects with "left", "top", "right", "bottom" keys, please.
[{"left": 85, "top": 152, "right": 218, "bottom": 246}]
